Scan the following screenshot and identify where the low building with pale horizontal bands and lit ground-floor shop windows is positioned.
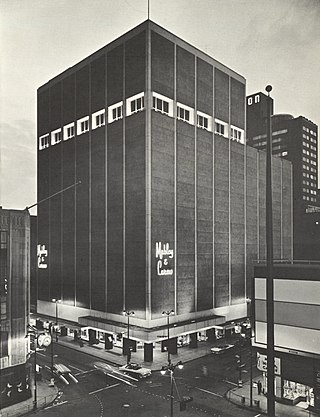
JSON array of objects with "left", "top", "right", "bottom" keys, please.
[{"left": 253, "top": 262, "right": 320, "bottom": 412}]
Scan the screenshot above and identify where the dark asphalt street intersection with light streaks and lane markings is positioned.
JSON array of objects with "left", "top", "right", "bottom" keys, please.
[{"left": 39, "top": 344, "right": 256, "bottom": 417}]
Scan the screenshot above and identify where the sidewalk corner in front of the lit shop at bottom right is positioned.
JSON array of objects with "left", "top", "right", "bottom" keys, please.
[{"left": 227, "top": 375, "right": 318, "bottom": 417}]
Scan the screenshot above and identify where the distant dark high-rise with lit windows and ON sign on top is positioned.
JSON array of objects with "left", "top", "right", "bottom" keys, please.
[{"left": 247, "top": 93, "right": 320, "bottom": 259}]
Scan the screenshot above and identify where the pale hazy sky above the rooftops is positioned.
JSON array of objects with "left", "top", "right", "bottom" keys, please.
[{"left": 0, "top": 0, "right": 320, "bottom": 213}]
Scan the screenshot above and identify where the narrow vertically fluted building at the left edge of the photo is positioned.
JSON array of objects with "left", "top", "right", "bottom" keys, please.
[{"left": 0, "top": 207, "right": 31, "bottom": 408}]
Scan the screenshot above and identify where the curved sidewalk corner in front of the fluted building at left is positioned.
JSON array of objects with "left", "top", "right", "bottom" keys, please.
[{"left": 0, "top": 380, "right": 58, "bottom": 417}]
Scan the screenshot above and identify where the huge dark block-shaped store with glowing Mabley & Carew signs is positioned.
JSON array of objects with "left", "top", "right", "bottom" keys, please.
[{"left": 37, "top": 21, "right": 292, "bottom": 360}]
